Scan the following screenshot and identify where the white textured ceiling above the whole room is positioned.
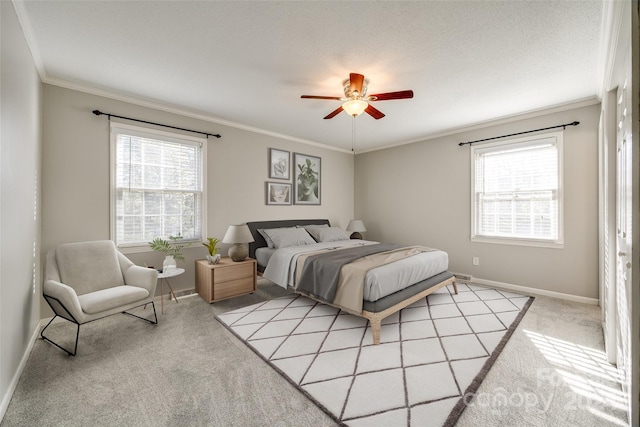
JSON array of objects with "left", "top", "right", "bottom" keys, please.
[{"left": 15, "top": 0, "right": 604, "bottom": 151}]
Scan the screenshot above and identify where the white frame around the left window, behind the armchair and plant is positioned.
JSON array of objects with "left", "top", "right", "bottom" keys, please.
[{"left": 109, "top": 121, "right": 207, "bottom": 254}]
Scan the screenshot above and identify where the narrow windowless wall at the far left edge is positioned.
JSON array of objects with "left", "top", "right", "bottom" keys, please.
[{"left": 0, "top": 1, "right": 42, "bottom": 419}]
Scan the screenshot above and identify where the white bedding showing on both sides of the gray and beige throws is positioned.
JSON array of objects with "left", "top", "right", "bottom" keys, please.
[{"left": 263, "top": 240, "right": 449, "bottom": 302}]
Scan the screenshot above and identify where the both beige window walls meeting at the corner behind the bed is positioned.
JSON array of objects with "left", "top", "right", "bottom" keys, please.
[{"left": 37, "top": 85, "right": 599, "bottom": 308}]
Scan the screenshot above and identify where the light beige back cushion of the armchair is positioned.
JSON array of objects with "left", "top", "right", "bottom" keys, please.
[{"left": 56, "top": 240, "right": 124, "bottom": 295}]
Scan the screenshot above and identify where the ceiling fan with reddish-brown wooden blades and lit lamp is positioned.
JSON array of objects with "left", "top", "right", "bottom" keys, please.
[{"left": 300, "top": 73, "right": 413, "bottom": 120}]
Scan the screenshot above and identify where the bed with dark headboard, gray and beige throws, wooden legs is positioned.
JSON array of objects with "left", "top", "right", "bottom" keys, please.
[{"left": 247, "top": 219, "right": 458, "bottom": 344}]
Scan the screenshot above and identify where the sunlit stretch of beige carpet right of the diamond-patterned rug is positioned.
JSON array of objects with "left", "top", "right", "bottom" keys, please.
[{"left": 456, "top": 296, "right": 629, "bottom": 427}]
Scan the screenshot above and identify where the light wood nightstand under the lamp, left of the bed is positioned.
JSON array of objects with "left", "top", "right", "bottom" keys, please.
[{"left": 196, "top": 257, "right": 257, "bottom": 303}]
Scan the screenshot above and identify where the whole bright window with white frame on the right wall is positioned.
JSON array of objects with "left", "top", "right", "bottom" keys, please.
[{"left": 471, "top": 132, "right": 562, "bottom": 247}]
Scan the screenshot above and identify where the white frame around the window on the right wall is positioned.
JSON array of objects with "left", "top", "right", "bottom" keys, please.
[{"left": 470, "top": 131, "right": 564, "bottom": 249}]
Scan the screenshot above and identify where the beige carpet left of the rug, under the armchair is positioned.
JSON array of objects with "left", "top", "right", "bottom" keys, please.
[{"left": 1, "top": 288, "right": 335, "bottom": 427}]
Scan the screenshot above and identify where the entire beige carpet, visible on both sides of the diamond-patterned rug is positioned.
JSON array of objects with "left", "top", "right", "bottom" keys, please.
[{"left": 1, "top": 281, "right": 626, "bottom": 427}]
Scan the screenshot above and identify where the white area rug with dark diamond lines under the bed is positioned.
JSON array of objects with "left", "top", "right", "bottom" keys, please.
[{"left": 216, "top": 283, "right": 533, "bottom": 427}]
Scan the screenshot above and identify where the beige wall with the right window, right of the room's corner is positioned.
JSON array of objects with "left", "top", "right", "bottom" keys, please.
[{"left": 355, "top": 105, "right": 600, "bottom": 298}]
